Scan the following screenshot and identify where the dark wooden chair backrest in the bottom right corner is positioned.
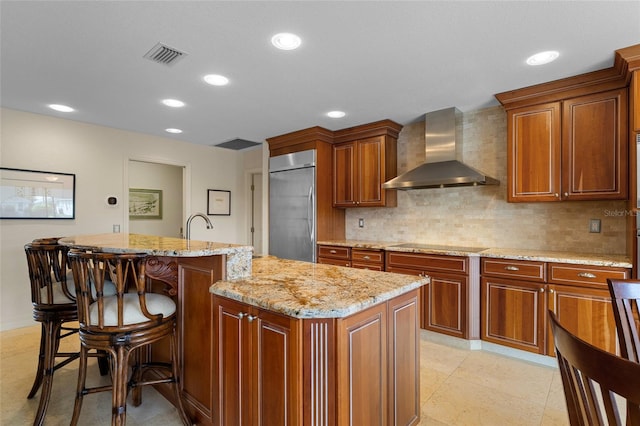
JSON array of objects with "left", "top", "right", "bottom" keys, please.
[{"left": 549, "top": 311, "right": 640, "bottom": 426}]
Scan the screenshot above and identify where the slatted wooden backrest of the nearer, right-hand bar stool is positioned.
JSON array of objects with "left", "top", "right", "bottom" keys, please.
[{"left": 69, "top": 250, "right": 162, "bottom": 332}]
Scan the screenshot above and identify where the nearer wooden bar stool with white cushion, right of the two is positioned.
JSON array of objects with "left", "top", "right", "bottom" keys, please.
[{"left": 69, "top": 250, "right": 191, "bottom": 425}]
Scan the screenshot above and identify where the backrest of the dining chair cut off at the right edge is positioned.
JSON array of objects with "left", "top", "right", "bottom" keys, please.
[{"left": 607, "top": 279, "right": 640, "bottom": 362}]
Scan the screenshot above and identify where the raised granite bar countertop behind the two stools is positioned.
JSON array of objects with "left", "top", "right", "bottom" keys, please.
[{"left": 60, "top": 233, "right": 253, "bottom": 257}]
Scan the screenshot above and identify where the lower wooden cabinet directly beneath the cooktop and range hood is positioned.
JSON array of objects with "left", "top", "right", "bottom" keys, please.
[{"left": 386, "top": 251, "right": 469, "bottom": 339}]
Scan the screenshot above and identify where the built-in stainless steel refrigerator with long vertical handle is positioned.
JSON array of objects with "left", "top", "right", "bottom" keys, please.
[{"left": 269, "top": 149, "right": 316, "bottom": 262}]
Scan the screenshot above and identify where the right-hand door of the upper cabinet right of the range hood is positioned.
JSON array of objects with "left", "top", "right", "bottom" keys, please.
[{"left": 562, "top": 89, "right": 628, "bottom": 200}]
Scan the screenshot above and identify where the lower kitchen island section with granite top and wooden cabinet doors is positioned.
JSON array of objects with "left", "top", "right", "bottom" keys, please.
[{"left": 211, "top": 257, "right": 429, "bottom": 425}]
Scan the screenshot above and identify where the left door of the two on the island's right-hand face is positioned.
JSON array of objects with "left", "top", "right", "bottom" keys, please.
[{"left": 337, "top": 303, "right": 388, "bottom": 426}]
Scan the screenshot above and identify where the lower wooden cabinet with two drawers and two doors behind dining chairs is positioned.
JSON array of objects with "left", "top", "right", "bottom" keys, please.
[{"left": 481, "top": 258, "right": 631, "bottom": 356}]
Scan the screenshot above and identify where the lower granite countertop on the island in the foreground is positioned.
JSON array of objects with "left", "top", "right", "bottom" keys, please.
[{"left": 210, "top": 256, "right": 429, "bottom": 318}]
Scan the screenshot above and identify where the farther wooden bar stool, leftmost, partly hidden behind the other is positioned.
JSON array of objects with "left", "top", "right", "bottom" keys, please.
[{"left": 24, "top": 238, "right": 115, "bottom": 425}]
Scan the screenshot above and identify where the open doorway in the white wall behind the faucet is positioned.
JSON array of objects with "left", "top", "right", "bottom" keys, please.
[{"left": 126, "top": 159, "right": 186, "bottom": 238}]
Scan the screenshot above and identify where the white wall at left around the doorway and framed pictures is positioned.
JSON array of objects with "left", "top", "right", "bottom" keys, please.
[{"left": 0, "top": 109, "right": 246, "bottom": 330}]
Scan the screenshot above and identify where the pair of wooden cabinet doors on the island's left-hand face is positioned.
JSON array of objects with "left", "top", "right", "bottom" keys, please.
[{"left": 212, "top": 297, "right": 302, "bottom": 425}]
